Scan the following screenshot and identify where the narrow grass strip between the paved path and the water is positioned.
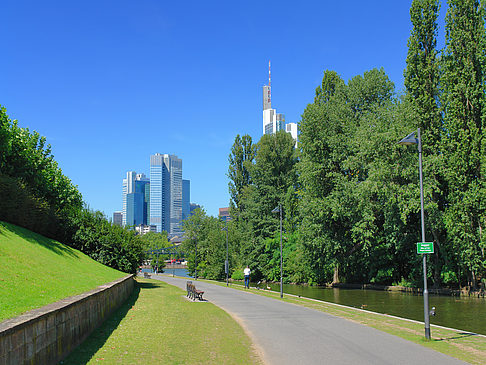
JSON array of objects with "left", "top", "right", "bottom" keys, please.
[{"left": 208, "top": 281, "right": 486, "bottom": 364}]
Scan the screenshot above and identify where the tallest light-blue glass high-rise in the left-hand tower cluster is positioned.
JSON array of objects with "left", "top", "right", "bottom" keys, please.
[{"left": 150, "top": 153, "right": 182, "bottom": 235}]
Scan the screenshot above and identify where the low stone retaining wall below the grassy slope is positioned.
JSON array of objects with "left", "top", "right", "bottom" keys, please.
[{"left": 0, "top": 275, "right": 134, "bottom": 365}]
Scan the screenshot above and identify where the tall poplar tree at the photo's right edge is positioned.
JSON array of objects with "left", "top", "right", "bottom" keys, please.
[{"left": 442, "top": 0, "right": 486, "bottom": 286}]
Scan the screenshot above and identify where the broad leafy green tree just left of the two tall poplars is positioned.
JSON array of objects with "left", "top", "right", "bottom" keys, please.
[{"left": 299, "top": 69, "right": 412, "bottom": 283}]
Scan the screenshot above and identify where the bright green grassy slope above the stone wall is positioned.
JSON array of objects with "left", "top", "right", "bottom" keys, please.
[{"left": 0, "top": 222, "right": 126, "bottom": 321}]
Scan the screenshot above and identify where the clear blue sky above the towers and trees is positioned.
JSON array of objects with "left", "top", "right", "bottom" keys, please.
[{"left": 0, "top": 0, "right": 446, "bottom": 217}]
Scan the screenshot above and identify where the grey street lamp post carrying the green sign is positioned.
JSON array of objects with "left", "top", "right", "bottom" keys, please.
[{"left": 398, "top": 128, "right": 430, "bottom": 340}]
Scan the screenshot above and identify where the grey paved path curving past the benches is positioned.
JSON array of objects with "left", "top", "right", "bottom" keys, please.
[{"left": 152, "top": 275, "right": 465, "bottom": 365}]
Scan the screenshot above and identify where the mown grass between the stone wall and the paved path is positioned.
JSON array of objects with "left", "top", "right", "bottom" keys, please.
[{"left": 62, "top": 278, "right": 262, "bottom": 365}]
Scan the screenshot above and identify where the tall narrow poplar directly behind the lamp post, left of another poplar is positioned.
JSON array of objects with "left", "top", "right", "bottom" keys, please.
[{"left": 404, "top": 0, "right": 448, "bottom": 283}]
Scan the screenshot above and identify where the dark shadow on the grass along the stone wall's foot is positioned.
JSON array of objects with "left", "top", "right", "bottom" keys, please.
[{"left": 60, "top": 282, "right": 140, "bottom": 365}]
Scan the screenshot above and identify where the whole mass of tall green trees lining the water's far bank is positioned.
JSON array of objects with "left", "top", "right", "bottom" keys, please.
[{"left": 208, "top": 0, "right": 486, "bottom": 286}]
